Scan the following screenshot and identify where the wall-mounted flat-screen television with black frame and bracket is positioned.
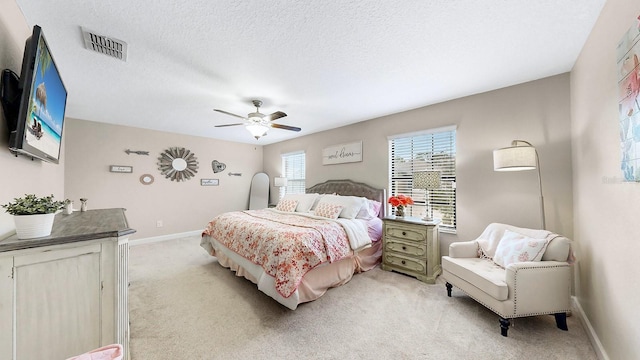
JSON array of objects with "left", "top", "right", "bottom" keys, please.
[{"left": 3, "top": 25, "right": 67, "bottom": 164}]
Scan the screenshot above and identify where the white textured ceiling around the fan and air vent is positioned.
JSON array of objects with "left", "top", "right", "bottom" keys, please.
[{"left": 17, "top": 0, "right": 605, "bottom": 145}]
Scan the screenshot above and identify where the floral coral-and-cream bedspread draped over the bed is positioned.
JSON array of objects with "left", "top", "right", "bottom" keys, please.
[{"left": 203, "top": 209, "right": 351, "bottom": 298}]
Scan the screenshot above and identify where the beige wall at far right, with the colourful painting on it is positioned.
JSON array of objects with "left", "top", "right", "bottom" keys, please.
[{"left": 571, "top": 0, "right": 640, "bottom": 359}]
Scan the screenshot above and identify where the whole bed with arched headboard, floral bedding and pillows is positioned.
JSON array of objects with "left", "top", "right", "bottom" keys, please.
[{"left": 200, "top": 180, "right": 386, "bottom": 310}]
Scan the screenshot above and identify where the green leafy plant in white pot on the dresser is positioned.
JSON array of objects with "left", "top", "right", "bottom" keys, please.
[{"left": 2, "top": 194, "right": 64, "bottom": 239}]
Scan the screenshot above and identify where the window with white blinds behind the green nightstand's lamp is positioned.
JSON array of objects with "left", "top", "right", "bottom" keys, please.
[{"left": 389, "top": 127, "right": 456, "bottom": 233}]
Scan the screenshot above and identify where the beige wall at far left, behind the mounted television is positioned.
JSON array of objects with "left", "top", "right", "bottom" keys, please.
[{"left": 0, "top": 0, "right": 64, "bottom": 239}]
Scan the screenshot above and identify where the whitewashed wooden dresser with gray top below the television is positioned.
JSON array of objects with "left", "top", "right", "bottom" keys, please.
[{"left": 0, "top": 209, "right": 135, "bottom": 360}]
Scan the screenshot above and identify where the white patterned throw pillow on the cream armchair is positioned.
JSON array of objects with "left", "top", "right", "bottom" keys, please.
[{"left": 493, "top": 230, "right": 548, "bottom": 268}]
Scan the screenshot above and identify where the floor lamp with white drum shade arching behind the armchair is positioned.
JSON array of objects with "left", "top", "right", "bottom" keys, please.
[{"left": 493, "top": 140, "right": 546, "bottom": 229}]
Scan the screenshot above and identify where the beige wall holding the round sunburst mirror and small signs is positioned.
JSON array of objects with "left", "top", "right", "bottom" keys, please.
[{"left": 65, "top": 118, "right": 262, "bottom": 239}]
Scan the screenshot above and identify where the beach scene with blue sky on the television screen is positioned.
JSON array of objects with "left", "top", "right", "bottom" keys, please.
[{"left": 25, "top": 38, "right": 67, "bottom": 159}]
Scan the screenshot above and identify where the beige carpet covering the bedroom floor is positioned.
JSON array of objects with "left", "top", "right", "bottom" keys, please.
[{"left": 129, "top": 237, "right": 597, "bottom": 360}]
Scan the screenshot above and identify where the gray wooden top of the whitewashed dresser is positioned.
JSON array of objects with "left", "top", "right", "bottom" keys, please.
[{"left": 0, "top": 209, "right": 136, "bottom": 252}]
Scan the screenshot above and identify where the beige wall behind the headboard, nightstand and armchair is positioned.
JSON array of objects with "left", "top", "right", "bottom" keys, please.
[{"left": 264, "top": 74, "right": 573, "bottom": 250}]
